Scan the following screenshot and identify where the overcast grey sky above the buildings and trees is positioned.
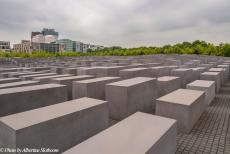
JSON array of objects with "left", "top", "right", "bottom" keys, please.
[{"left": 0, "top": 0, "right": 230, "bottom": 47}]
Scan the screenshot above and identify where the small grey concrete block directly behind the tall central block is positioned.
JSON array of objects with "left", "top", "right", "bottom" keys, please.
[{"left": 119, "top": 67, "right": 151, "bottom": 79}]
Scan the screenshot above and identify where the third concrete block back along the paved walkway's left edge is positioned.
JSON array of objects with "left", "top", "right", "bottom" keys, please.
[{"left": 200, "top": 72, "right": 221, "bottom": 93}]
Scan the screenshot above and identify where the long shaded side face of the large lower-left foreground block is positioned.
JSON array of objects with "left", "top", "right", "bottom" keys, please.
[{"left": 17, "top": 103, "right": 108, "bottom": 152}]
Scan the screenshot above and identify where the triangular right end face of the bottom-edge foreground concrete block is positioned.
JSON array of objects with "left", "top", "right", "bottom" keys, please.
[{"left": 146, "top": 123, "right": 177, "bottom": 154}]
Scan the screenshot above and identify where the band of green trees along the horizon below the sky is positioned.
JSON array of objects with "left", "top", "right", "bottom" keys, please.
[{"left": 0, "top": 40, "right": 230, "bottom": 58}]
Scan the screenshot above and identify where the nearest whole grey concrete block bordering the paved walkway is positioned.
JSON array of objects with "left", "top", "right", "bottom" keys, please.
[{"left": 156, "top": 89, "right": 205, "bottom": 133}]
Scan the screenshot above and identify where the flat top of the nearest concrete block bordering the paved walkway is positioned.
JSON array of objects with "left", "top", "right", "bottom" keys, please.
[{"left": 157, "top": 89, "right": 204, "bottom": 106}]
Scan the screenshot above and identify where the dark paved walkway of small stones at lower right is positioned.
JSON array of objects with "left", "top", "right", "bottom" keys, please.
[{"left": 176, "top": 81, "right": 230, "bottom": 154}]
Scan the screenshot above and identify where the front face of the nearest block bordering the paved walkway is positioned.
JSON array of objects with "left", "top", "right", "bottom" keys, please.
[{"left": 156, "top": 100, "right": 191, "bottom": 133}]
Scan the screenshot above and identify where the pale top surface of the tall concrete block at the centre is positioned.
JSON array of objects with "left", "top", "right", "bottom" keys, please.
[{"left": 107, "top": 77, "right": 156, "bottom": 87}]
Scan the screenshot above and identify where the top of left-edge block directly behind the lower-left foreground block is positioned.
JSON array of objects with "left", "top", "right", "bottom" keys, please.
[{"left": 0, "top": 84, "right": 65, "bottom": 95}]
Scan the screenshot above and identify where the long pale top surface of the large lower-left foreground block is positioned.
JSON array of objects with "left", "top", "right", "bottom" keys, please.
[{"left": 0, "top": 97, "right": 107, "bottom": 130}]
